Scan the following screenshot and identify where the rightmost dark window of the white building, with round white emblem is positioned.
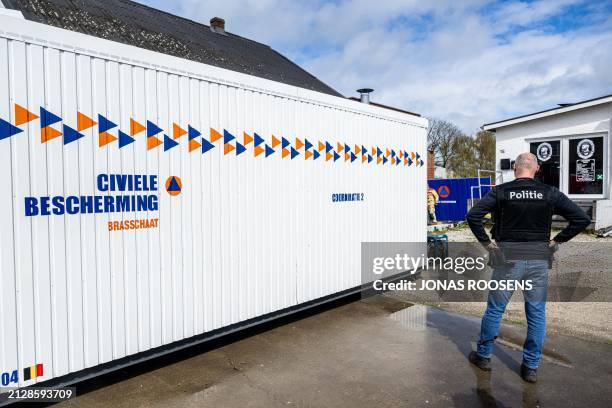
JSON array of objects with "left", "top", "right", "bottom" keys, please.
[{"left": 567, "top": 136, "right": 604, "bottom": 195}]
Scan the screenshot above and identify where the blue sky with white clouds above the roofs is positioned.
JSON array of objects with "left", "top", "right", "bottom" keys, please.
[{"left": 140, "top": 0, "right": 612, "bottom": 134}]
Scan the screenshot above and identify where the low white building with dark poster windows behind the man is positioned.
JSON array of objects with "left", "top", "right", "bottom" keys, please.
[{"left": 482, "top": 95, "right": 612, "bottom": 230}]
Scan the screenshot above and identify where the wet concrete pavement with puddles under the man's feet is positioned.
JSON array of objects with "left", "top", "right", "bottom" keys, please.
[{"left": 58, "top": 296, "right": 612, "bottom": 408}]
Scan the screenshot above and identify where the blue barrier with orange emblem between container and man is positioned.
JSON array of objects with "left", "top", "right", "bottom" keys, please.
[{"left": 427, "top": 177, "right": 491, "bottom": 221}]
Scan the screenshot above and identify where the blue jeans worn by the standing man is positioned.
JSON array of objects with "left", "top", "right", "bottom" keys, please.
[{"left": 477, "top": 259, "right": 548, "bottom": 369}]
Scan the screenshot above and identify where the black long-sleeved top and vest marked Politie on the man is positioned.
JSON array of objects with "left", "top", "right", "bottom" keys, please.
[{"left": 467, "top": 178, "right": 591, "bottom": 245}]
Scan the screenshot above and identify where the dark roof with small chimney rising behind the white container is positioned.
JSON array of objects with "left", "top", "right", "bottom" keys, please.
[{"left": 0, "top": 0, "right": 342, "bottom": 96}]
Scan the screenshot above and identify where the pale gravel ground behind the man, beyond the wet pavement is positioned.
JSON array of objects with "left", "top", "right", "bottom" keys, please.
[{"left": 392, "top": 225, "right": 612, "bottom": 344}]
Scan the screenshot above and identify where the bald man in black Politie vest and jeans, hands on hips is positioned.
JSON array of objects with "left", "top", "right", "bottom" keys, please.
[{"left": 467, "top": 153, "right": 591, "bottom": 382}]
